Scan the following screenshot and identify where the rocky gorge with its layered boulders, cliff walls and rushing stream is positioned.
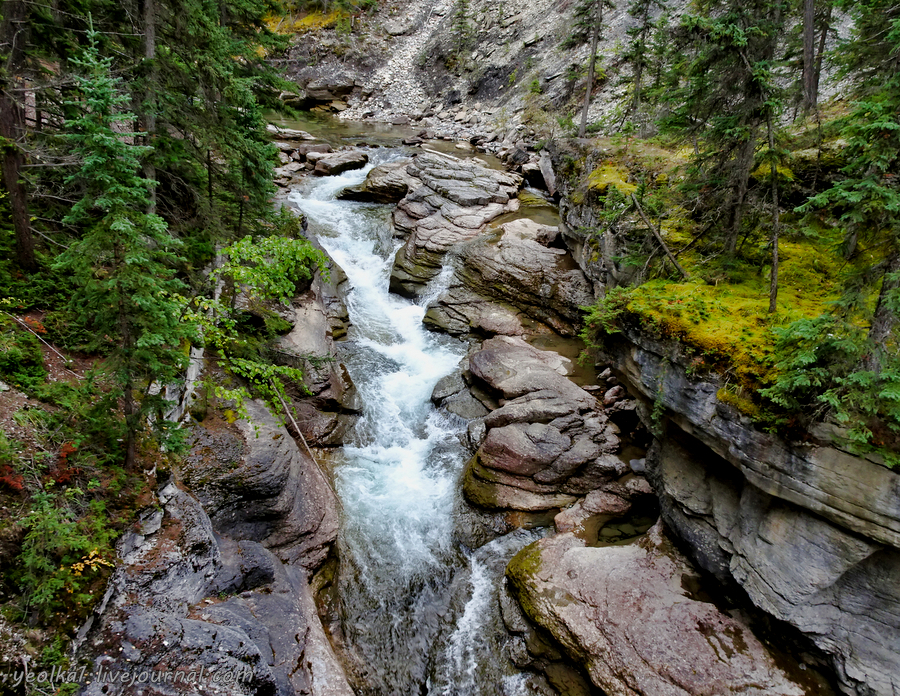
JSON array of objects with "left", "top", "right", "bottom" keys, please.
[{"left": 68, "top": 121, "right": 900, "bottom": 696}]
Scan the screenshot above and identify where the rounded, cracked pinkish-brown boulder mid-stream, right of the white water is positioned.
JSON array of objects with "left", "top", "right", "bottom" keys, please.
[{"left": 447, "top": 336, "right": 629, "bottom": 512}]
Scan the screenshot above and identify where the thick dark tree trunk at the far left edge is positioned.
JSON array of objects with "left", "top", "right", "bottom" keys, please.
[{"left": 0, "top": 0, "right": 36, "bottom": 271}]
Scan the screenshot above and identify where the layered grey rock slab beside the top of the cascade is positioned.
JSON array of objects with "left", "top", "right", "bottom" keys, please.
[{"left": 391, "top": 152, "right": 522, "bottom": 297}]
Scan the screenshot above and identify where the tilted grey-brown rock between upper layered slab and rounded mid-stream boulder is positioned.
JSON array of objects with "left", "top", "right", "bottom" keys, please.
[{"left": 425, "top": 219, "right": 593, "bottom": 336}]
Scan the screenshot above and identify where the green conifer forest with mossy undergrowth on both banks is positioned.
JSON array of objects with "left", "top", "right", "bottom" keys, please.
[{"left": 0, "top": 0, "right": 900, "bottom": 680}]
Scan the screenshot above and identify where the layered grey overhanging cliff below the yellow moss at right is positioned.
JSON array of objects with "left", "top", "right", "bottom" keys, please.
[{"left": 609, "top": 335, "right": 900, "bottom": 696}]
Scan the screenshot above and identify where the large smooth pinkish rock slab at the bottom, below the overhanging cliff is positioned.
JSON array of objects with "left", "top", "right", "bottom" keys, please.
[{"left": 507, "top": 524, "right": 807, "bottom": 696}]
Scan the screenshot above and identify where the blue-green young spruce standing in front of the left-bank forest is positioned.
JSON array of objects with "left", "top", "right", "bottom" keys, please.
[{"left": 56, "top": 30, "right": 188, "bottom": 466}]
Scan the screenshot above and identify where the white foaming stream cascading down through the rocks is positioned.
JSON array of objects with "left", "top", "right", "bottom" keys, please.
[{"left": 293, "top": 150, "right": 552, "bottom": 696}]
